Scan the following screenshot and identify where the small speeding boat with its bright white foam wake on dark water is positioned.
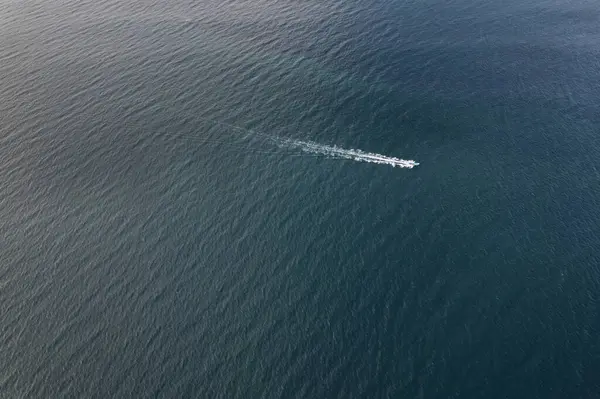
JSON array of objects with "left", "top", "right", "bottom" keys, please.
[{"left": 273, "top": 137, "right": 419, "bottom": 169}]
